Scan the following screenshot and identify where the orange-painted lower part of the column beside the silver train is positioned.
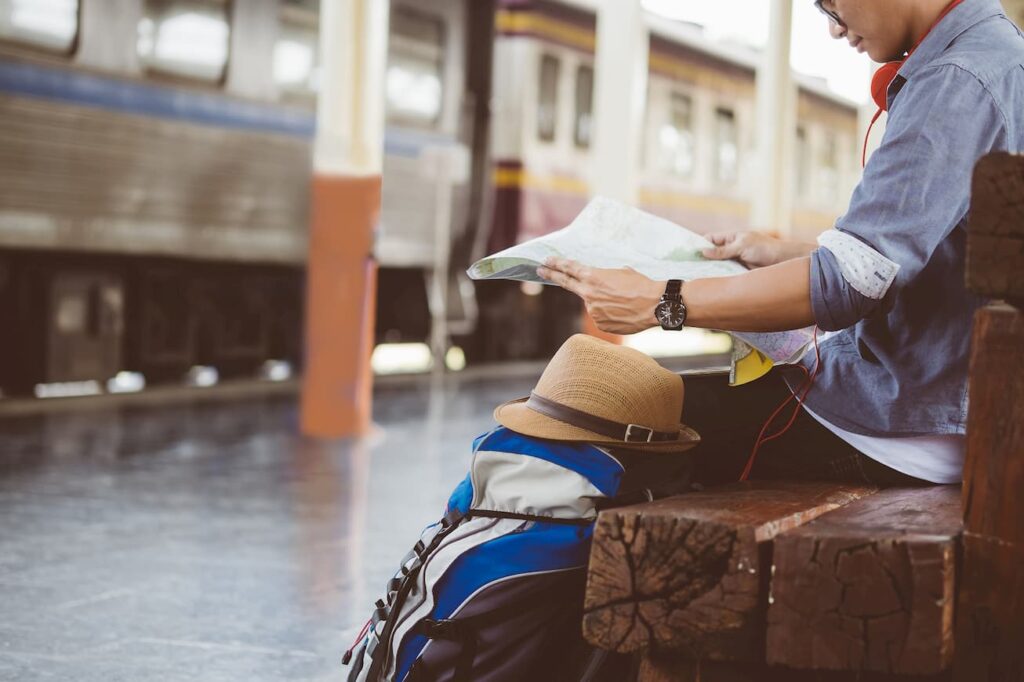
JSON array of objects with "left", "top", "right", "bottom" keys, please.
[{"left": 302, "top": 176, "right": 381, "bottom": 438}]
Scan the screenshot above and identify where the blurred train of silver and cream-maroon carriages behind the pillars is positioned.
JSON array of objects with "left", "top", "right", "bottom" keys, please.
[{"left": 0, "top": 0, "right": 859, "bottom": 395}]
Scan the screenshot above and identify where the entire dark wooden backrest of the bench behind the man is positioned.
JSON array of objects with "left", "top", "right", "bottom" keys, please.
[{"left": 953, "top": 154, "right": 1024, "bottom": 682}]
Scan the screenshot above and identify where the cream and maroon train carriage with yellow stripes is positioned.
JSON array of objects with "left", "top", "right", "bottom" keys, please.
[{"left": 475, "top": 0, "right": 859, "bottom": 359}]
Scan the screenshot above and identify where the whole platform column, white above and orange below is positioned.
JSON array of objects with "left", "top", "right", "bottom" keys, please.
[{"left": 301, "top": 0, "right": 390, "bottom": 438}]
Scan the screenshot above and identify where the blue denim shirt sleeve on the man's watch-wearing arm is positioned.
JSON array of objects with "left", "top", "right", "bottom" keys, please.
[{"left": 810, "top": 63, "right": 1007, "bottom": 331}]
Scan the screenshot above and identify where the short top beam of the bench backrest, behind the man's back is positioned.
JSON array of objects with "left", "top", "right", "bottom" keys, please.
[{"left": 967, "top": 153, "right": 1024, "bottom": 301}]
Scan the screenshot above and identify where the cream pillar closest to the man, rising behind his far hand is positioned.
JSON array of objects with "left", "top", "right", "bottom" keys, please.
[{"left": 751, "top": 0, "right": 797, "bottom": 237}]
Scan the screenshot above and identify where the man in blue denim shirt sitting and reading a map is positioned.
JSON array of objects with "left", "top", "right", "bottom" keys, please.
[{"left": 539, "top": 0, "right": 1024, "bottom": 483}]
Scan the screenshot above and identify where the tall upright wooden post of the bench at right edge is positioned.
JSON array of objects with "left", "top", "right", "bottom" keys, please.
[{"left": 953, "top": 305, "right": 1024, "bottom": 682}]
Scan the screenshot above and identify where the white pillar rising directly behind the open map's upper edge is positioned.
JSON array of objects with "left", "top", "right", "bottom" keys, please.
[{"left": 590, "top": 0, "right": 649, "bottom": 204}]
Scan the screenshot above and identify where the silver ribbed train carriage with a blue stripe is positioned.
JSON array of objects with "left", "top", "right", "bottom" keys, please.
[{"left": 0, "top": 0, "right": 479, "bottom": 394}]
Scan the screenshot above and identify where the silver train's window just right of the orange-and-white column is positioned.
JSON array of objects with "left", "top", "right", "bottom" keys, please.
[{"left": 385, "top": 7, "right": 444, "bottom": 127}]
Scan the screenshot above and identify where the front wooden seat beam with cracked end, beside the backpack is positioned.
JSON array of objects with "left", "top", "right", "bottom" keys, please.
[{"left": 583, "top": 482, "right": 874, "bottom": 660}]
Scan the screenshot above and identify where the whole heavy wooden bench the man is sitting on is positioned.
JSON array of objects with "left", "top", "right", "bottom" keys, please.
[{"left": 583, "top": 154, "right": 1024, "bottom": 682}]
